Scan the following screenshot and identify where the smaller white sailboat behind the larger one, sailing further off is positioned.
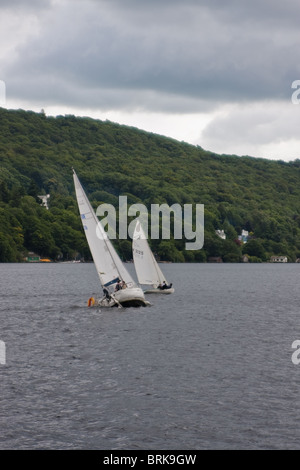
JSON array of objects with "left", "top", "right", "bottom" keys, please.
[{"left": 132, "top": 221, "right": 174, "bottom": 294}]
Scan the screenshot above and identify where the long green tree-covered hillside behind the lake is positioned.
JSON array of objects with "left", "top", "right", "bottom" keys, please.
[{"left": 0, "top": 108, "right": 300, "bottom": 262}]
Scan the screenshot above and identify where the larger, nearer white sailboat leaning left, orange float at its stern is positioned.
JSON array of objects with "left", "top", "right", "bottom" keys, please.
[{"left": 73, "top": 169, "right": 149, "bottom": 307}]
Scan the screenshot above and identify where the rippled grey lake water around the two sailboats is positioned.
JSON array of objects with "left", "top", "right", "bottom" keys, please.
[{"left": 0, "top": 264, "right": 300, "bottom": 450}]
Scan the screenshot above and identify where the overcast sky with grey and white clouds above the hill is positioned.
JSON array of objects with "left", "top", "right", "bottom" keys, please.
[{"left": 0, "top": 0, "right": 300, "bottom": 161}]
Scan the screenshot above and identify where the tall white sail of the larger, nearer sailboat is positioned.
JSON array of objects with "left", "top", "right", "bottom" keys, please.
[{"left": 73, "top": 170, "right": 135, "bottom": 287}]
